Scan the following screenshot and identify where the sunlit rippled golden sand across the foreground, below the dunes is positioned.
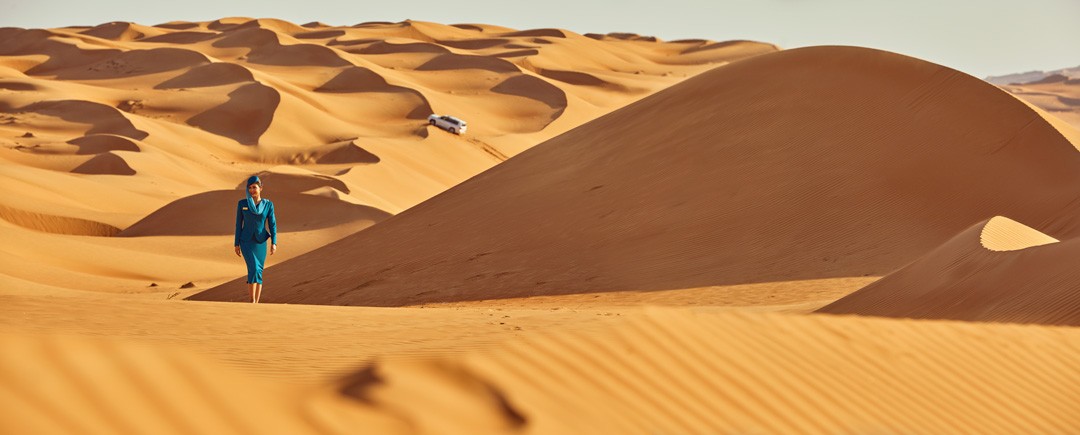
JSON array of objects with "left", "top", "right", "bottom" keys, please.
[{"left": 0, "top": 297, "right": 1080, "bottom": 434}]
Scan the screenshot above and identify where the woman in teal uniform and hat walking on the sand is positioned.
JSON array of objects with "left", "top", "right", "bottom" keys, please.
[{"left": 232, "top": 175, "right": 278, "bottom": 303}]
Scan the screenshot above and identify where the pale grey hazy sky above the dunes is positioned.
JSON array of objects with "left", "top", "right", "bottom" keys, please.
[{"left": 0, "top": 0, "right": 1080, "bottom": 78}]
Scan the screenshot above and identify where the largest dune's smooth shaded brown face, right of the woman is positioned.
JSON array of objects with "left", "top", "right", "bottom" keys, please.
[{"left": 195, "top": 47, "right": 1080, "bottom": 305}]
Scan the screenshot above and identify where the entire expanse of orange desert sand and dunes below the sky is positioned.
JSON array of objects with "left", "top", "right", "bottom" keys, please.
[{"left": 0, "top": 17, "right": 1080, "bottom": 434}]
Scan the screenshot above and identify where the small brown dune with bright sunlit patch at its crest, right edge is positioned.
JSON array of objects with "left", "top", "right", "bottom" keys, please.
[{"left": 819, "top": 216, "right": 1080, "bottom": 326}]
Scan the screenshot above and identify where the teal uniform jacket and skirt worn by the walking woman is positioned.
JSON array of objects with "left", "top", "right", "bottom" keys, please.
[{"left": 232, "top": 194, "right": 278, "bottom": 284}]
